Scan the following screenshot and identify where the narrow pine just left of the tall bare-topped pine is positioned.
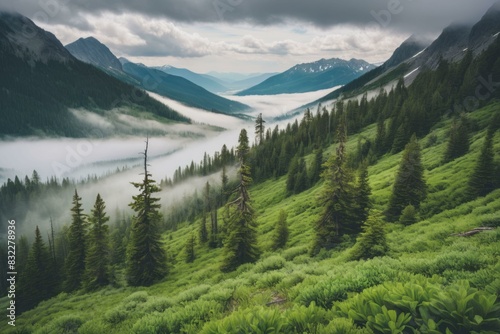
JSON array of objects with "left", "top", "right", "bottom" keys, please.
[{"left": 84, "top": 194, "right": 111, "bottom": 290}]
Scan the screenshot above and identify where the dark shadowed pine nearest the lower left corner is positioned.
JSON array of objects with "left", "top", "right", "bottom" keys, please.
[{"left": 16, "top": 226, "right": 52, "bottom": 312}]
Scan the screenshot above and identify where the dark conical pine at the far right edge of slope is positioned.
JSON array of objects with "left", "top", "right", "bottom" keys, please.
[{"left": 469, "top": 127, "right": 498, "bottom": 197}]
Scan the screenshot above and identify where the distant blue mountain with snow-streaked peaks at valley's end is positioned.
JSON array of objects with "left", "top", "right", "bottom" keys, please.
[{"left": 237, "top": 58, "right": 375, "bottom": 96}]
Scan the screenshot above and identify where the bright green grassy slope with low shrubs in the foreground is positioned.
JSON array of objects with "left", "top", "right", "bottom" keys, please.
[{"left": 0, "top": 103, "right": 500, "bottom": 333}]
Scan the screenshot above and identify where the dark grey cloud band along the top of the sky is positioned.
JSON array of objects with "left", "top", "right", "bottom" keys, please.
[{"left": 0, "top": 0, "right": 495, "bottom": 32}]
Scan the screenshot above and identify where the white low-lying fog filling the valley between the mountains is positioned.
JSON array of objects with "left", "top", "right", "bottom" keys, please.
[{"left": 0, "top": 90, "right": 336, "bottom": 233}]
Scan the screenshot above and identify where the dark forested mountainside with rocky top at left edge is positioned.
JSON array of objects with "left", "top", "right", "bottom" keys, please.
[{"left": 0, "top": 12, "right": 189, "bottom": 137}]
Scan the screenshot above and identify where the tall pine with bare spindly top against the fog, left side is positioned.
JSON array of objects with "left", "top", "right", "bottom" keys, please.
[{"left": 127, "top": 140, "right": 167, "bottom": 286}]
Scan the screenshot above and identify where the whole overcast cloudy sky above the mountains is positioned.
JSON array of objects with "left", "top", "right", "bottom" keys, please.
[{"left": 0, "top": 0, "right": 495, "bottom": 73}]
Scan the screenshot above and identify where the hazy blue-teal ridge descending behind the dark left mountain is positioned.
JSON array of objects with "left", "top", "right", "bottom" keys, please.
[{"left": 120, "top": 58, "right": 250, "bottom": 114}]
